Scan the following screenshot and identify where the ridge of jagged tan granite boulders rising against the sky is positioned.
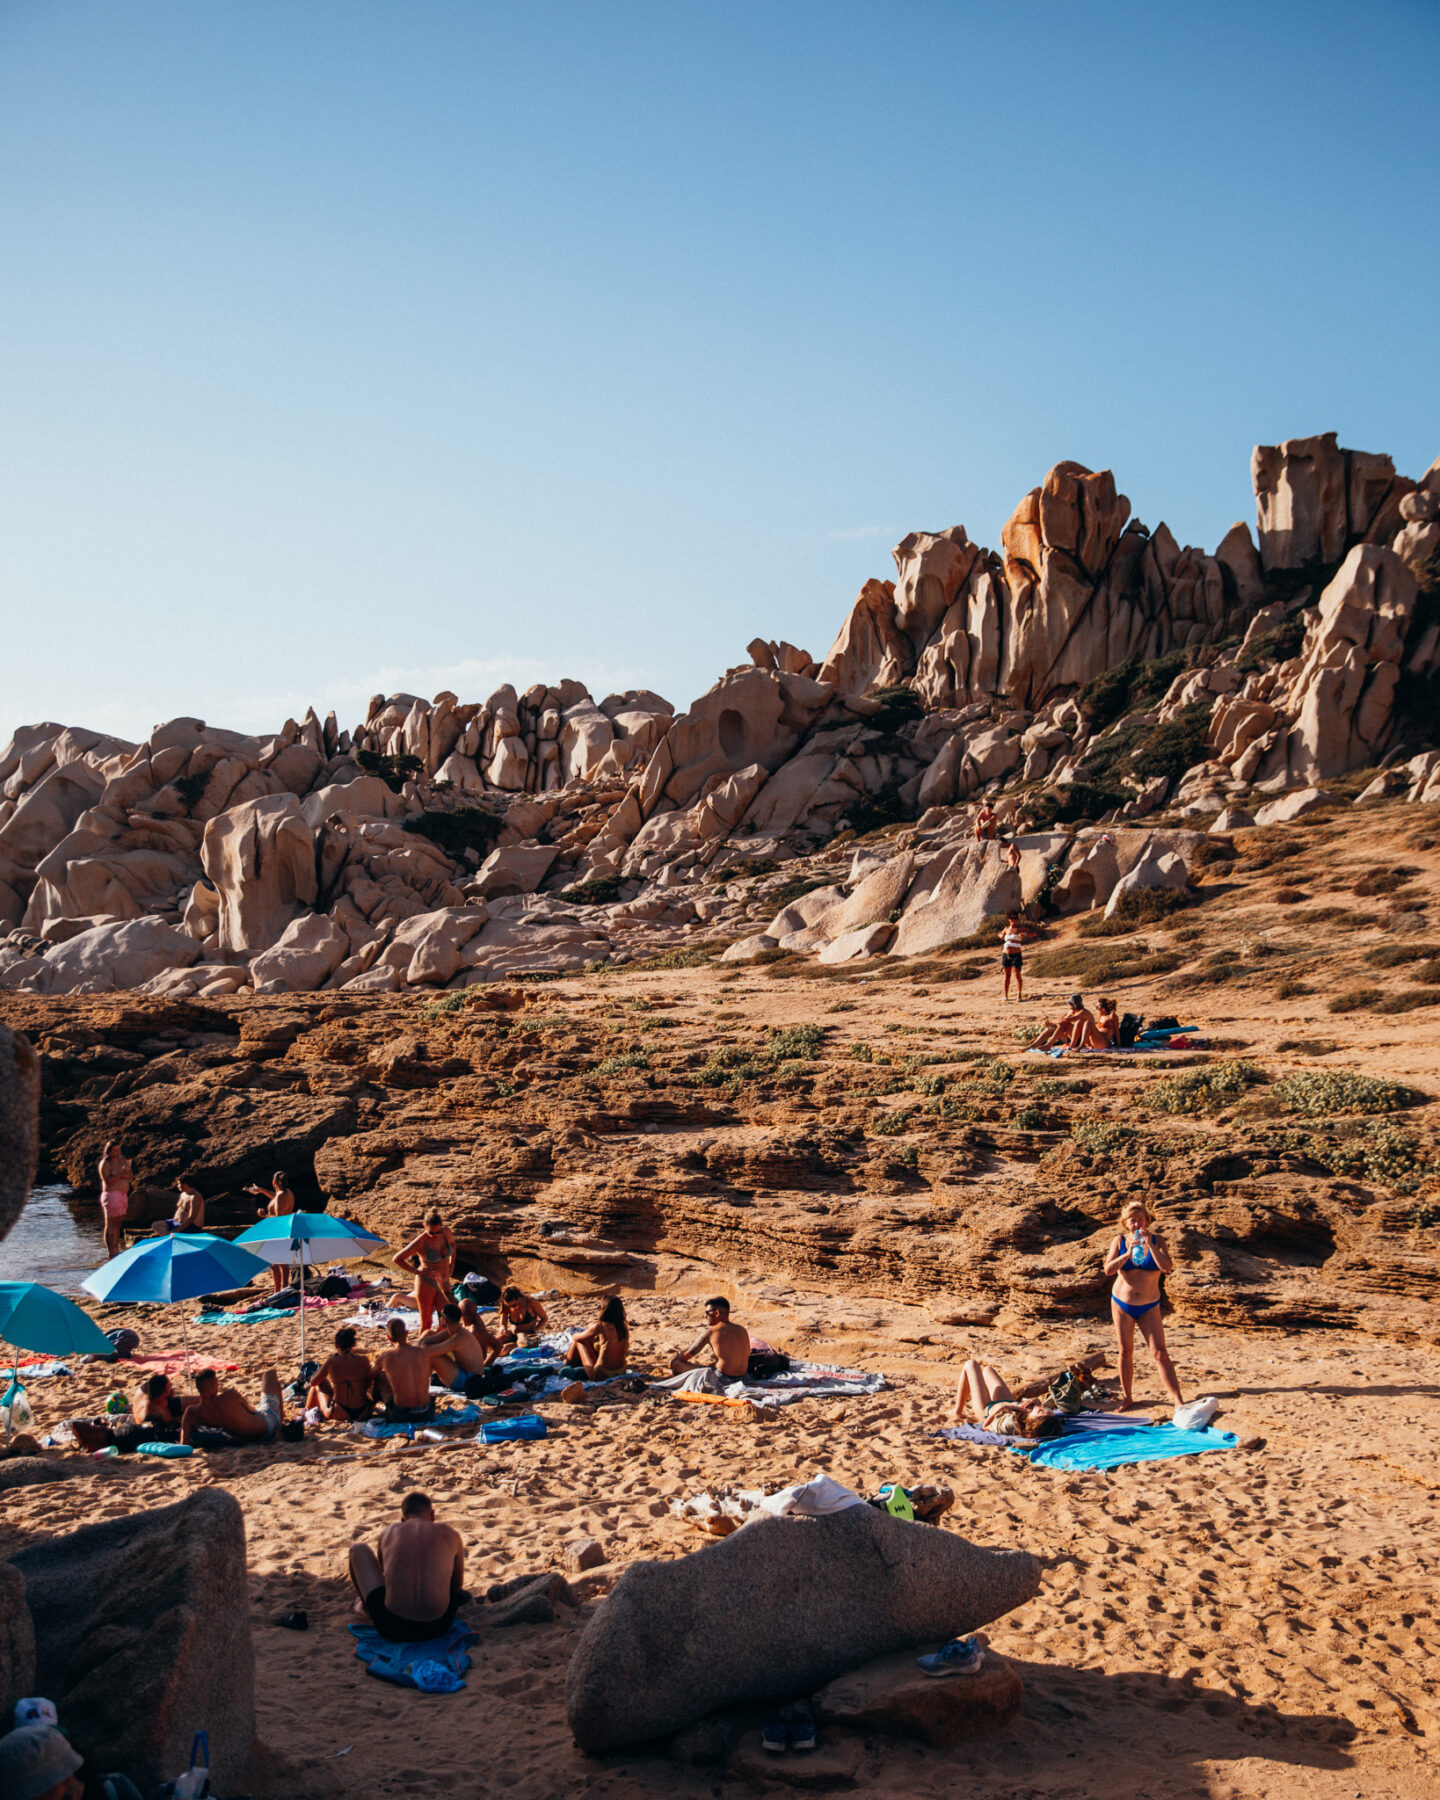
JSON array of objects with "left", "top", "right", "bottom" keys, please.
[{"left": 0, "top": 434, "right": 1440, "bottom": 997}]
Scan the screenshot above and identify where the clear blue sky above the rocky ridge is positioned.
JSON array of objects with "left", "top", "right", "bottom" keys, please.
[{"left": 0, "top": 0, "right": 1440, "bottom": 740}]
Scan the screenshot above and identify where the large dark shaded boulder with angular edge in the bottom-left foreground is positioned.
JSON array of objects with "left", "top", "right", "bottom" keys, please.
[{"left": 13, "top": 1489, "right": 256, "bottom": 1795}]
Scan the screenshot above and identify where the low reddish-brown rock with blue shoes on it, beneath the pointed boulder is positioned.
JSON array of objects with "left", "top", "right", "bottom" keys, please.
[{"left": 814, "top": 1649, "right": 1024, "bottom": 1744}]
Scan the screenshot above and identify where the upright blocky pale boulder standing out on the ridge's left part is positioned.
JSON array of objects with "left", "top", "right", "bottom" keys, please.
[{"left": 200, "top": 794, "right": 317, "bottom": 956}]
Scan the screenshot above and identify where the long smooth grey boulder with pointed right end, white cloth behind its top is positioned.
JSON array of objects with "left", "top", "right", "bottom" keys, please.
[{"left": 565, "top": 1507, "right": 1040, "bottom": 1751}]
